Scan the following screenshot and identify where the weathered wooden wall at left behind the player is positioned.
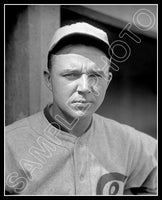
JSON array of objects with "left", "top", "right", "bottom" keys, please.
[{"left": 5, "top": 5, "right": 60, "bottom": 125}]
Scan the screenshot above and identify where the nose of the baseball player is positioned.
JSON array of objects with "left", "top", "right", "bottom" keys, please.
[{"left": 77, "top": 74, "right": 90, "bottom": 93}]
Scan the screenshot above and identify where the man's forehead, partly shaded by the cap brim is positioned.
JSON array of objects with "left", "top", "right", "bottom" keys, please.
[{"left": 53, "top": 45, "right": 109, "bottom": 69}]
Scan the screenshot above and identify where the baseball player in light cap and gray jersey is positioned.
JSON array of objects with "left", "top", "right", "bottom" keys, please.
[{"left": 5, "top": 22, "right": 157, "bottom": 195}]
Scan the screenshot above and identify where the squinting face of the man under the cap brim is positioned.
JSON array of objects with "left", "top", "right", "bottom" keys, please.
[{"left": 47, "top": 45, "right": 109, "bottom": 118}]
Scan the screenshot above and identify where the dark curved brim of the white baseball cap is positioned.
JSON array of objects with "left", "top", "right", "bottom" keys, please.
[{"left": 50, "top": 33, "right": 110, "bottom": 59}]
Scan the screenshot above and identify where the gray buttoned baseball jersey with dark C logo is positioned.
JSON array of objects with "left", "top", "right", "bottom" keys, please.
[{"left": 5, "top": 104, "right": 157, "bottom": 195}]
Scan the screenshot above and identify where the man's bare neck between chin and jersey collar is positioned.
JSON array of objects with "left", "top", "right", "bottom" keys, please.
[{"left": 49, "top": 104, "right": 92, "bottom": 137}]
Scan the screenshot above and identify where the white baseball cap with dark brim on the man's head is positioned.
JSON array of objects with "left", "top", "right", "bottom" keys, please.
[{"left": 49, "top": 22, "right": 110, "bottom": 58}]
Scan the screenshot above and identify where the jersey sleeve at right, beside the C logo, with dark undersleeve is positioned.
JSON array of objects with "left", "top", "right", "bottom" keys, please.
[{"left": 124, "top": 129, "right": 157, "bottom": 195}]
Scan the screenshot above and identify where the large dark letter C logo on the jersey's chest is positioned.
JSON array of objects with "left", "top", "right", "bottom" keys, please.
[{"left": 96, "top": 172, "right": 126, "bottom": 195}]
